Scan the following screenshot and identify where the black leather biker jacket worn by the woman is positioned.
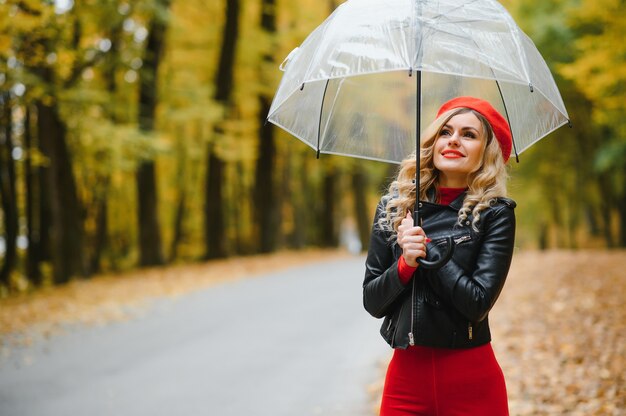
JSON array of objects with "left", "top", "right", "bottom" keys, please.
[{"left": 363, "top": 193, "right": 515, "bottom": 348}]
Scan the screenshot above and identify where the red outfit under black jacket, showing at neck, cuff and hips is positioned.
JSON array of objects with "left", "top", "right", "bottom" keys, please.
[{"left": 380, "top": 188, "right": 509, "bottom": 416}]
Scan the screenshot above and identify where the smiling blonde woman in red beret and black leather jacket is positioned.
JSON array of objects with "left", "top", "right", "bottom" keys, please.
[{"left": 363, "top": 97, "right": 515, "bottom": 416}]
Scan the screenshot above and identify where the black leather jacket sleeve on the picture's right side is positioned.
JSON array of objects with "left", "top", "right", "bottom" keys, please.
[{"left": 427, "top": 205, "right": 515, "bottom": 322}]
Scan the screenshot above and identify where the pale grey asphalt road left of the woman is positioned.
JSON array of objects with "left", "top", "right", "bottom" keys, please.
[{"left": 0, "top": 257, "right": 390, "bottom": 416}]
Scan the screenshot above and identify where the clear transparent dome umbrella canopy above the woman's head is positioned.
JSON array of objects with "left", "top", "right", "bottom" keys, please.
[{"left": 268, "top": 0, "right": 569, "bottom": 163}]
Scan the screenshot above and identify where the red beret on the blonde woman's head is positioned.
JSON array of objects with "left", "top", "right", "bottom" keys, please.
[{"left": 437, "top": 97, "right": 513, "bottom": 162}]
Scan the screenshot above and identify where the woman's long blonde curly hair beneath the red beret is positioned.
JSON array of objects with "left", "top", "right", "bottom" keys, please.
[{"left": 378, "top": 108, "right": 508, "bottom": 239}]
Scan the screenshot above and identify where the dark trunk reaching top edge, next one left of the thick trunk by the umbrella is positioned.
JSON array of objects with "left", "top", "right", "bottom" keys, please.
[{"left": 136, "top": 0, "right": 170, "bottom": 266}]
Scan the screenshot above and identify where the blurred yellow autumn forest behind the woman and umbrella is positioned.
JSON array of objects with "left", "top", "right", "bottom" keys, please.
[{"left": 0, "top": 0, "right": 626, "bottom": 295}]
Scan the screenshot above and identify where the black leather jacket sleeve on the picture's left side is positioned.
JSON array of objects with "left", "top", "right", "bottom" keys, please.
[{"left": 363, "top": 202, "right": 406, "bottom": 318}]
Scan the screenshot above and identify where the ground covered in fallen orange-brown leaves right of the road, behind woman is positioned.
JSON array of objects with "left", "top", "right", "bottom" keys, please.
[{"left": 370, "top": 251, "right": 626, "bottom": 416}]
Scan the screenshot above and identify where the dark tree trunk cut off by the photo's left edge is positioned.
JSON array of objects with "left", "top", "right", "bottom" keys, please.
[{"left": 0, "top": 92, "right": 18, "bottom": 287}]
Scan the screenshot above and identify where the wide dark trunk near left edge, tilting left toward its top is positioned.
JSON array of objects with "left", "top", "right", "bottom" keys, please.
[{"left": 37, "top": 101, "right": 86, "bottom": 283}]
